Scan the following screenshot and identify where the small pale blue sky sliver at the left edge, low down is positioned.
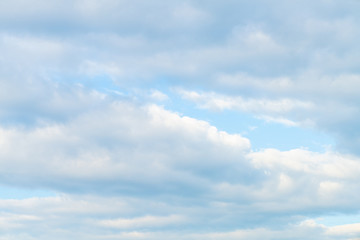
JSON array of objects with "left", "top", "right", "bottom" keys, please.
[{"left": 0, "top": 185, "right": 56, "bottom": 200}]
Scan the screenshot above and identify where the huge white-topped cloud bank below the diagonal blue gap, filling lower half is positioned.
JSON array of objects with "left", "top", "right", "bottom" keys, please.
[{"left": 0, "top": 83, "right": 360, "bottom": 239}]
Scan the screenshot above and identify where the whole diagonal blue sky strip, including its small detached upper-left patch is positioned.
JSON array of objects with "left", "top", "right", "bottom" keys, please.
[{"left": 55, "top": 71, "right": 335, "bottom": 152}]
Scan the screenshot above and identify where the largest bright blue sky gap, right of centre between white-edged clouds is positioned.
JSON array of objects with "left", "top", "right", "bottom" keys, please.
[{"left": 162, "top": 90, "right": 335, "bottom": 152}]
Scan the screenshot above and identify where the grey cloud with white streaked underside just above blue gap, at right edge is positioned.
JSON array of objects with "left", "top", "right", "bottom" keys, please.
[{"left": 176, "top": 83, "right": 360, "bottom": 154}]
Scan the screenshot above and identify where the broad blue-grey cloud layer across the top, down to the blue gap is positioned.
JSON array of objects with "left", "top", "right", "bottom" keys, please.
[{"left": 0, "top": 0, "right": 359, "bottom": 153}]
